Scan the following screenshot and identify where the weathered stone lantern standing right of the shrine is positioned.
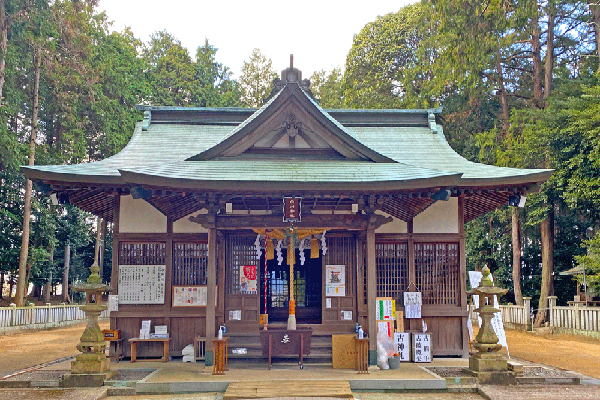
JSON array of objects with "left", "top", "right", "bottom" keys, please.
[{"left": 467, "top": 266, "right": 515, "bottom": 383}]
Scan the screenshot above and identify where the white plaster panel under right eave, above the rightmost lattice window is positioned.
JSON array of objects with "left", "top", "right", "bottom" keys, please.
[{"left": 413, "top": 197, "right": 459, "bottom": 233}]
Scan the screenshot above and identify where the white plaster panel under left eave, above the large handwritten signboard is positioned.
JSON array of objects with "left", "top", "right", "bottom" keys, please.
[{"left": 119, "top": 196, "right": 167, "bottom": 233}]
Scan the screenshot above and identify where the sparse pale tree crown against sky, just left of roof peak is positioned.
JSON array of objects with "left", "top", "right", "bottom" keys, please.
[{"left": 240, "top": 49, "right": 277, "bottom": 107}]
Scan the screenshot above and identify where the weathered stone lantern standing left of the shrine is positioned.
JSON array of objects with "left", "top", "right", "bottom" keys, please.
[{"left": 63, "top": 262, "right": 114, "bottom": 386}]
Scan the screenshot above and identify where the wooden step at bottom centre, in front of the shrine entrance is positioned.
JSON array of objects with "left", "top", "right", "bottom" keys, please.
[{"left": 223, "top": 380, "right": 353, "bottom": 400}]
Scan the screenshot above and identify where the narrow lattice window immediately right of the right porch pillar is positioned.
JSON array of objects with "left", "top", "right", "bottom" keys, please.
[{"left": 375, "top": 243, "right": 408, "bottom": 300}]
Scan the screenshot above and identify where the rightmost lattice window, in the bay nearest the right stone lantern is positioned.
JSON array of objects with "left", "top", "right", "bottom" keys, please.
[{"left": 415, "top": 243, "right": 460, "bottom": 305}]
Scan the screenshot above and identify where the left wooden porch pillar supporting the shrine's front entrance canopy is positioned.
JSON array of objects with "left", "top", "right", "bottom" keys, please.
[{"left": 206, "top": 213, "right": 217, "bottom": 366}]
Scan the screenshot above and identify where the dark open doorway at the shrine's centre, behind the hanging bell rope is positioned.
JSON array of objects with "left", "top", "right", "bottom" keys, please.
[{"left": 258, "top": 249, "right": 323, "bottom": 324}]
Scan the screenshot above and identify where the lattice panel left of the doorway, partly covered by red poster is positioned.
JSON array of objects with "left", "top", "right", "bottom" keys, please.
[{"left": 226, "top": 236, "right": 256, "bottom": 294}]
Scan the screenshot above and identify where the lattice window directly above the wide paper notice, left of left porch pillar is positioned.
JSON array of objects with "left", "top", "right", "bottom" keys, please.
[{"left": 172, "top": 243, "right": 208, "bottom": 285}]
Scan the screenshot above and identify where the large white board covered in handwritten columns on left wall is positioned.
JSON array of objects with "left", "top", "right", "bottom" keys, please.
[{"left": 119, "top": 265, "right": 166, "bottom": 304}]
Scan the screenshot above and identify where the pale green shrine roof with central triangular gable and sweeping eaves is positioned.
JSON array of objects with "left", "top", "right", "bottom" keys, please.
[{"left": 22, "top": 65, "right": 552, "bottom": 220}]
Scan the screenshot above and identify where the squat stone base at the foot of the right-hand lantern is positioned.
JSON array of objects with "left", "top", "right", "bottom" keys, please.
[{"left": 468, "top": 352, "right": 517, "bottom": 385}]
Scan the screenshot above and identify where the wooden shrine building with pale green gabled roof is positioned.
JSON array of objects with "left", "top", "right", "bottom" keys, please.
[{"left": 22, "top": 63, "right": 551, "bottom": 364}]
